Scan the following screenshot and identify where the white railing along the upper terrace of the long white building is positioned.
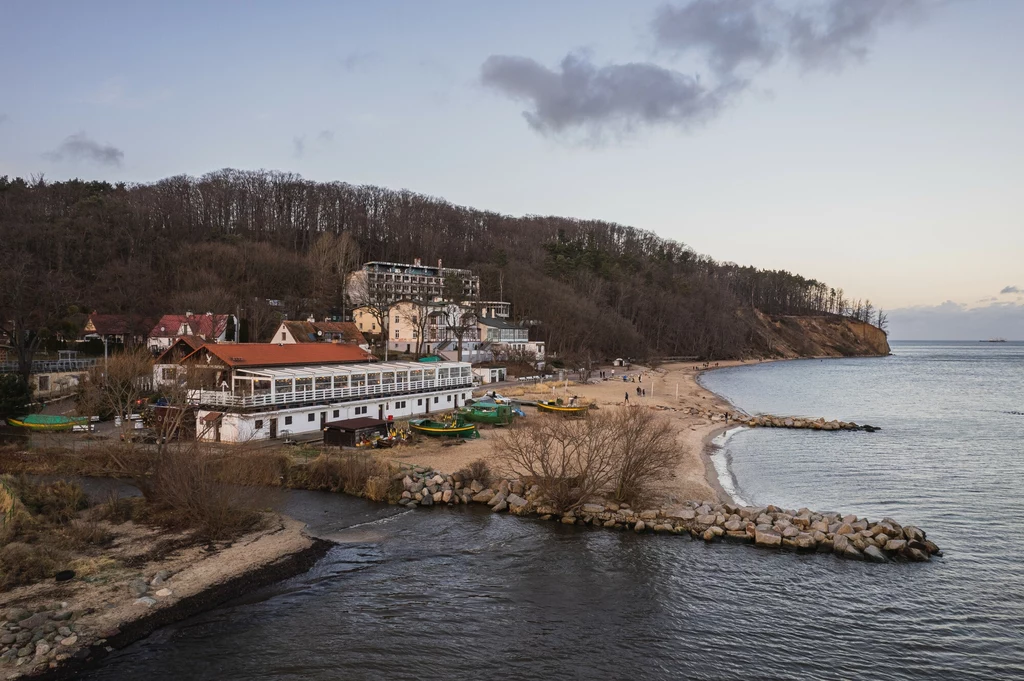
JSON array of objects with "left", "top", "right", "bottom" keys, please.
[{"left": 188, "top": 376, "right": 473, "bottom": 409}]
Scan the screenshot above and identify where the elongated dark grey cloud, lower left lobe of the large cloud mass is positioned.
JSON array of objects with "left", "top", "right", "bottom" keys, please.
[{"left": 480, "top": 54, "right": 733, "bottom": 133}]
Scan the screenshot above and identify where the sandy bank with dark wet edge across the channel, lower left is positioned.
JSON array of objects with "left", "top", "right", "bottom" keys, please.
[{"left": 0, "top": 515, "right": 333, "bottom": 681}]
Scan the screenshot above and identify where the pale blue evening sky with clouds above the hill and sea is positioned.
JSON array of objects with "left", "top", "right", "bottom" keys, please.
[{"left": 0, "top": 0, "right": 1024, "bottom": 340}]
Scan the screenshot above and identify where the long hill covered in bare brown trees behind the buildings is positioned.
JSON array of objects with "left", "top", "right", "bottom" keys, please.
[{"left": 0, "top": 169, "right": 884, "bottom": 358}]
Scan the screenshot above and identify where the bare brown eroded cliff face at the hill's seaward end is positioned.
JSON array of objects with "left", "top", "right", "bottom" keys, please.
[{"left": 740, "top": 310, "right": 889, "bottom": 357}]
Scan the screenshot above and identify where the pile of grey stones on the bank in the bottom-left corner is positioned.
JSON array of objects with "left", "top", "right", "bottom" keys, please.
[{"left": 0, "top": 602, "right": 89, "bottom": 671}]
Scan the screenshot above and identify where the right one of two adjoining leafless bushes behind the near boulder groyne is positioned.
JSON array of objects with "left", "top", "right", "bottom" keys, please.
[{"left": 608, "top": 406, "right": 682, "bottom": 505}]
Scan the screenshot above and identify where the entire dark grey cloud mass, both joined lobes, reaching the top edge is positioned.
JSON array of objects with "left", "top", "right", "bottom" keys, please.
[{"left": 480, "top": 0, "right": 930, "bottom": 134}]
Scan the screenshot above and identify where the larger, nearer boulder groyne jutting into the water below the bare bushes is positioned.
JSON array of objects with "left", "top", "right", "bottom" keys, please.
[{"left": 396, "top": 466, "right": 942, "bottom": 562}]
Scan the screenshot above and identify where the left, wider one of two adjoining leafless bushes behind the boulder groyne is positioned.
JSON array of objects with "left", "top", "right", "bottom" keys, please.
[{"left": 495, "top": 417, "right": 615, "bottom": 511}]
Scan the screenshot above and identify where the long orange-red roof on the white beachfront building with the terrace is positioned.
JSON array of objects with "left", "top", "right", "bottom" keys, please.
[{"left": 182, "top": 343, "right": 376, "bottom": 369}]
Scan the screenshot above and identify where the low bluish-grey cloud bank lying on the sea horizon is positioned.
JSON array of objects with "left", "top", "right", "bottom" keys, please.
[{"left": 887, "top": 300, "right": 1024, "bottom": 340}]
